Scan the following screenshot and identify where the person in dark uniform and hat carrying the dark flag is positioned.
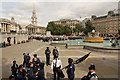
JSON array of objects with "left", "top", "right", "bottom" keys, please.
[{"left": 66, "top": 58, "right": 75, "bottom": 80}]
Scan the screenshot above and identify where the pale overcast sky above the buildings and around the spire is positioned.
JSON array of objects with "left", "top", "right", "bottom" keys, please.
[{"left": 2, "top": 2, "right": 118, "bottom": 27}]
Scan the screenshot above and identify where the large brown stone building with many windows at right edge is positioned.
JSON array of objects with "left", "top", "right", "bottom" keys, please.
[{"left": 91, "top": 11, "right": 120, "bottom": 36}]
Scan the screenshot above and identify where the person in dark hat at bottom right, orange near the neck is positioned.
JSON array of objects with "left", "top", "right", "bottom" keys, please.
[{"left": 81, "top": 64, "right": 98, "bottom": 80}]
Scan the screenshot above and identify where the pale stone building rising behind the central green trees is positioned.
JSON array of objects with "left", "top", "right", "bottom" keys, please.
[{"left": 52, "top": 19, "right": 80, "bottom": 28}]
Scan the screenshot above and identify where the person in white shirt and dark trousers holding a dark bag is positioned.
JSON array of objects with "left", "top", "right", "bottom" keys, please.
[{"left": 51, "top": 55, "right": 62, "bottom": 80}]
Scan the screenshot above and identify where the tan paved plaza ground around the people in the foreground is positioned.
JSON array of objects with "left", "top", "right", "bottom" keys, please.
[{"left": 2, "top": 40, "right": 118, "bottom": 79}]
